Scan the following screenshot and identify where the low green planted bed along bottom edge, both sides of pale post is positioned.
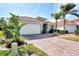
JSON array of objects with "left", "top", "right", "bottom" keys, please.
[{"left": 0, "top": 44, "right": 48, "bottom": 56}]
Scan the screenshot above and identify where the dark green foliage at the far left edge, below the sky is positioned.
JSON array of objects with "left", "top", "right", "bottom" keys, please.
[{"left": 0, "top": 17, "right": 12, "bottom": 38}]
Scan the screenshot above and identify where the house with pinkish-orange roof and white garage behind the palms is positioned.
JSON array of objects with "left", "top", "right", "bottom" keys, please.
[{"left": 53, "top": 18, "right": 79, "bottom": 33}]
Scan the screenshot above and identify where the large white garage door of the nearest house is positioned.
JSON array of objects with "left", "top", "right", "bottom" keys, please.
[{"left": 20, "top": 24, "right": 41, "bottom": 35}]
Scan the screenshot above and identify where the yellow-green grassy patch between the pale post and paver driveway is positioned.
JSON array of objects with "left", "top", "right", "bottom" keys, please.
[{"left": 21, "top": 44, "right": 48, "bottom": 56}]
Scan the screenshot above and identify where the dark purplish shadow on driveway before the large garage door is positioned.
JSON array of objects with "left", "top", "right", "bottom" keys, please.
[{"left": 22, "top": 34, "right": 54, "bottom": 40}]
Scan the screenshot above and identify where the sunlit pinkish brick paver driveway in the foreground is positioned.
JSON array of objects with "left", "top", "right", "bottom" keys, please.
[{"left": 22, "top": 35, "right": 79, "bottom": 56}]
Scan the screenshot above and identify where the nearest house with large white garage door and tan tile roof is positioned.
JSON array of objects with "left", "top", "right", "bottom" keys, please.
[{"left": 19, "top": 16, "right": 51, "bottom": 35}]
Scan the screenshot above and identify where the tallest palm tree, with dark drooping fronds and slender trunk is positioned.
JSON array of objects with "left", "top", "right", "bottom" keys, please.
[{"left": 60, "top": 3, "right": 79, "bottom": 34}]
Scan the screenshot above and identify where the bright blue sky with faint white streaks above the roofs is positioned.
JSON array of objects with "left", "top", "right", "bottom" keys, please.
[{"left": 0, "top": 3, "right": 79, "bottom": 20}]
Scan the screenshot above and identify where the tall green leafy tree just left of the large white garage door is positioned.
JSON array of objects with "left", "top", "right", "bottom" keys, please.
[{"left": 9, "top": 13, "right": 25, "bottom": 42}]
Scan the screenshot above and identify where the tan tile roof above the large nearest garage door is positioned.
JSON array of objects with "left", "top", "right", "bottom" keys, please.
[{"left": 19, "top": 16, "right": 46, "bottom": 24}]
